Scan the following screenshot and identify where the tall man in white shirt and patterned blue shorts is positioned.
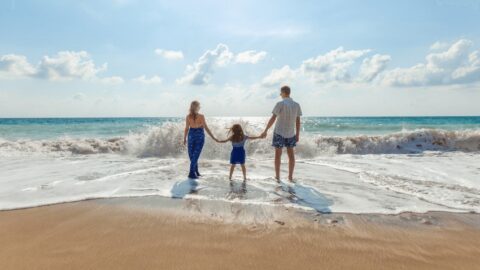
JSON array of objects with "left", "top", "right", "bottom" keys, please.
[{"left": 262, "top": 86, "right": 302, "bottom": 182}]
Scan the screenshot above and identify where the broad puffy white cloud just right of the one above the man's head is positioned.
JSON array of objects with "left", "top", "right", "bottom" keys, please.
[{"left": 300, "top": 47, "right": 370, "bottom": 82}]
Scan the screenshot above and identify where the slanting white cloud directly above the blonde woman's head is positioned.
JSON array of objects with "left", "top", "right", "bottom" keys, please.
[{"left": 177, "top": 43, "right": 233, "bottom": 85}]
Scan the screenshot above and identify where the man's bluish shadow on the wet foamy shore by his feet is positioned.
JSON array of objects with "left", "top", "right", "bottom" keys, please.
[{"left": 276, "top": 183, "right": 333, "bottom": 214}]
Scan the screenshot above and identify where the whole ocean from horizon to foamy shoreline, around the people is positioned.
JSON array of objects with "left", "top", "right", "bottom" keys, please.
[{"left": 0, "top": 117, "right": 480, "bottom": 213}]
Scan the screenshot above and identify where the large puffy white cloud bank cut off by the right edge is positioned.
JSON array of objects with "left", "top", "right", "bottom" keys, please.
[{"left": 383, "top": 39, "right": 480, "bottom": 86}]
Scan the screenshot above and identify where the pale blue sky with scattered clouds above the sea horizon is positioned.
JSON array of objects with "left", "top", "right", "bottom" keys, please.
[{"left": 0, "top": 0, "right": 480, "bottom": 117}]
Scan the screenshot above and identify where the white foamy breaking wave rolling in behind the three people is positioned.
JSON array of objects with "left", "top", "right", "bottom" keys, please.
[{"left": 0, "top": 123, "right": 480, "bottom": 159}]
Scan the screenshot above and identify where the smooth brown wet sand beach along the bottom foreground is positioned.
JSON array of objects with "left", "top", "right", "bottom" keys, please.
[{"left": 0, "top": 197, "right": 480, "bottom": 269}]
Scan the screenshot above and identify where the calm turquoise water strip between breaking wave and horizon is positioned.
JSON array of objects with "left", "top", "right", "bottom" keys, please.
[{"left": 0, "top": 116, "right": 480, "bottom": 139}]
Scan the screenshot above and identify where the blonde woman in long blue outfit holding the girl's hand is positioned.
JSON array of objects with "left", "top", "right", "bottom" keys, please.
[{"left": 183, "top": 100, "right": 217, "bottom": 179}]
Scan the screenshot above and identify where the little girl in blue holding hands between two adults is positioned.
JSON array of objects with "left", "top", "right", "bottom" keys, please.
[{"left": 216, "top": 124, "right": 261, "bottom": 180}]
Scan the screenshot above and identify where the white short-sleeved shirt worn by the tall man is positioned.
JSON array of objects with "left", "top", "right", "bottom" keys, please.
[{"left": 272, "top": 98, "right": 302, "bottom": 138}]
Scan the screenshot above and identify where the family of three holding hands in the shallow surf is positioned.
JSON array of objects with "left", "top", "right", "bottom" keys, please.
[{"left": 183, "top": 86, "right": 302, "bottom": 182}]
